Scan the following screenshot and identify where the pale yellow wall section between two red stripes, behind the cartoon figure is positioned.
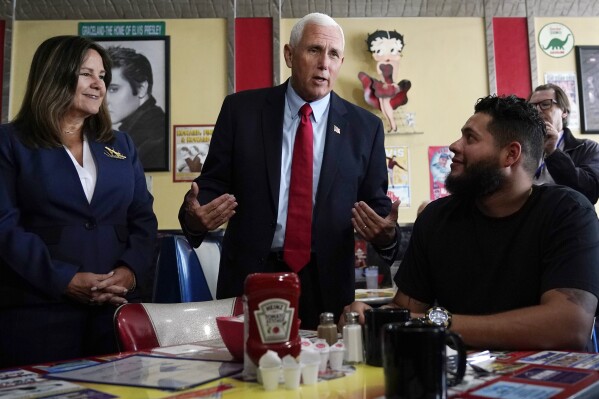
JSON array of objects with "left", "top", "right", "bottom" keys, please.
[{"left": 281, "top": 18, "right": 489, "bottom": 223}]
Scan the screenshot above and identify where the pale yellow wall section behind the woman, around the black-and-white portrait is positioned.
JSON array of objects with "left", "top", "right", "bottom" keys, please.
[{"left": 9, "top": 18, "right": 227, "bottom": 229}]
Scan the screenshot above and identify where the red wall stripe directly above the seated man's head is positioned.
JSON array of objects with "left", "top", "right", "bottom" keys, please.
[{"left": 493, "top": 17, "right": 532, "bottom": 98}]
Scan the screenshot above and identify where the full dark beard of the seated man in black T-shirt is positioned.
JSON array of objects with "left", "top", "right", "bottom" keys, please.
[{"left": 445, "top": 160, "right": 506, "bottom": 199}]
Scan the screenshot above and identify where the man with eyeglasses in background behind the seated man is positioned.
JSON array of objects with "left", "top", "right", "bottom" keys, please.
[{"left": 529, "top": 83, "right": 599, "bottom": 204}]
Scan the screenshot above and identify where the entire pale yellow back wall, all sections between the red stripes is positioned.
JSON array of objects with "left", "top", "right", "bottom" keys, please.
[{"left": 9, "top": 18, "right": 599, "bottom": 229}]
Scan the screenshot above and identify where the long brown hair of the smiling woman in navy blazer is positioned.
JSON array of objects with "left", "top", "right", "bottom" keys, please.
[{"left": 13, "top": 36, "right": 114, "bottom": 148}]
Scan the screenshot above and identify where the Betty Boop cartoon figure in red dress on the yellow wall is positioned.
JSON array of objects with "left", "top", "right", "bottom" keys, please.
[{"left": 358, "top": 30, "right": 414, "bottom": 133}]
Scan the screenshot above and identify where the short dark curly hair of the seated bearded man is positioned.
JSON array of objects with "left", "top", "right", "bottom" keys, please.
[{"left": 474, "top": 95, "right": 546, "bottom": 176}]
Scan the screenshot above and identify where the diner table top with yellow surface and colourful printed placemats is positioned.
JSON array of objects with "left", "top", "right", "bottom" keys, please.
[{"left": 0, "top": 330, "right": 599, "bottom": 399}]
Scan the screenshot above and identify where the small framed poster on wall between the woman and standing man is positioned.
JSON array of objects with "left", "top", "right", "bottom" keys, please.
[{"left": 173, "top": 125, "right": 214, "bottom": 182}]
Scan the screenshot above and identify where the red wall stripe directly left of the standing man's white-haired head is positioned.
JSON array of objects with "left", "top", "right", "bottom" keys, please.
[{"left": 235, "top": 18, "right": 273, "bottom": 91}]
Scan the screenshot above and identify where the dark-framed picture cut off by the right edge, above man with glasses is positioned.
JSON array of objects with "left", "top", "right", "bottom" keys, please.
[{"left": 576, "top": 46, "right": 599, "bottom": 133}]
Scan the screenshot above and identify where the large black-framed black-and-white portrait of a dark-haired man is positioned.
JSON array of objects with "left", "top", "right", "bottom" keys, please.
[{"left": 95, "top": 36, "right": 170, "bottom": 172}]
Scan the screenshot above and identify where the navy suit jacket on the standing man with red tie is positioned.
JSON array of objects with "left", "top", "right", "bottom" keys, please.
[{"left": 179, "top": 83, "right": 399, "bottom": 315}]
